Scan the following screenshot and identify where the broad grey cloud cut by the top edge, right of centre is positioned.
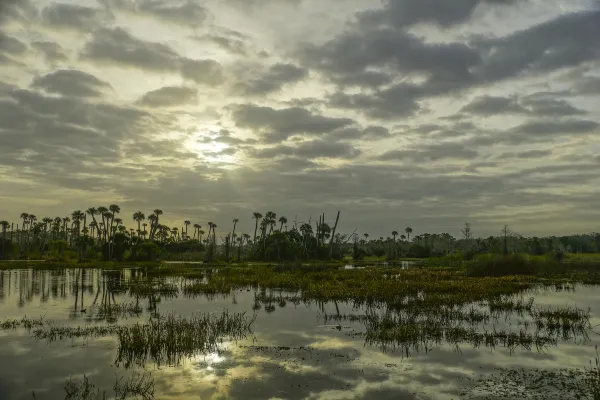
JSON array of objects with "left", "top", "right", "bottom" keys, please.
[{"left": 359, "top": 0, "right": 522, "bottom": 28}]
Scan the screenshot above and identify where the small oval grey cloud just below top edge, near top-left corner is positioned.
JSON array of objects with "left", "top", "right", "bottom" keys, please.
[{"left": 41, "top": 3, "right": 111, "bottom": 32}]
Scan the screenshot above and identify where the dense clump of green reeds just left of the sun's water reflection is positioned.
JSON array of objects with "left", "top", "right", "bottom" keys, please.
[{"left": 116, "top": 311, "right": 254, "bottom": 367}]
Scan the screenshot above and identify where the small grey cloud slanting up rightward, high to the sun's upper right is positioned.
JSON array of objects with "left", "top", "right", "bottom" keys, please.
[{"left": 238, "top": 63, "right": 308, "bottom": 96}]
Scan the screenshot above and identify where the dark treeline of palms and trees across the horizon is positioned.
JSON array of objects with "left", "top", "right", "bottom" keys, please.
[{"left": 0, "top": 204, "right": 600, "bottom": 262}]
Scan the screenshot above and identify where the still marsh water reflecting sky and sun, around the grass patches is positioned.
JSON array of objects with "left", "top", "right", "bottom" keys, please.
[{"left": 0, "top": 269, "right": 600, "bottom": 400}]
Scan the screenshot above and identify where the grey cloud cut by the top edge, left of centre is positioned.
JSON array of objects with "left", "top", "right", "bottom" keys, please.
[{"left": 105, "top": 0, "right": 210, "bottom": 28}]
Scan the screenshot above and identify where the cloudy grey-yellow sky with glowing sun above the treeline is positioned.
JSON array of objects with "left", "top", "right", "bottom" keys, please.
[{"left": 0, "top": 0, "right": 600, "bottom": 237}]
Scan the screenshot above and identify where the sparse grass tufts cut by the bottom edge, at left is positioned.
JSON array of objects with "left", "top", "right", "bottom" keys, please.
[{"left": 61, "top": 372, "right": 154, "bottom": 400}]
